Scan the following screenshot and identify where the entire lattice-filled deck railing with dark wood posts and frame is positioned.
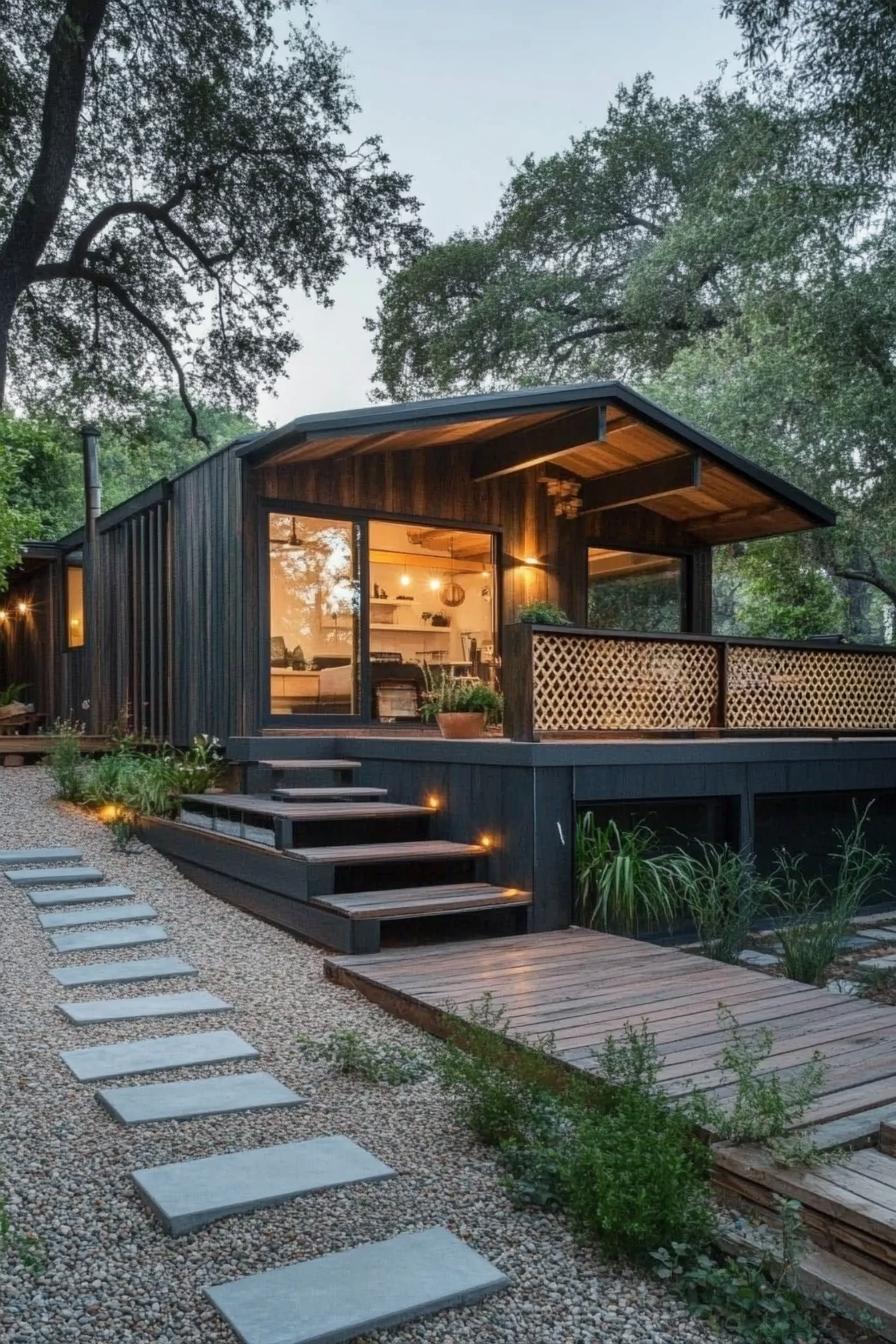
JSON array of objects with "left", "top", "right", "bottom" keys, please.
[{"left": 504, "top": 625, "right": 896, "bottom": 741}]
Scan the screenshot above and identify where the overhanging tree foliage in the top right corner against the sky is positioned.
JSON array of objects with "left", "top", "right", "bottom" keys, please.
[{"left": 723, "top": 0, "right": 896, "bottom": 176}]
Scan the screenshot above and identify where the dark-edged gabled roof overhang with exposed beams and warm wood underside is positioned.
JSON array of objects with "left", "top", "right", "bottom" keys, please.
[{"left": 236, "top": 382, "right": 836, "bottom": 546}]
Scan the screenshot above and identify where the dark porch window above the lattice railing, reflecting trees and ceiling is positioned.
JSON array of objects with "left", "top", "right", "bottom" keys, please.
[{"left": 588, "top": 547, "right": 682, "bottom": 634}]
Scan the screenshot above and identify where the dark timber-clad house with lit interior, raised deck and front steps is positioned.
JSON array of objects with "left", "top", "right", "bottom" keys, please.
[{"left": 1, "top": 382, "right": 896, "bottom": 949}]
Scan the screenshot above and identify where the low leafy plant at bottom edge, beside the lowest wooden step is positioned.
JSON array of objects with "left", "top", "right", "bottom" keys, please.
[{"left": 652, "top": 1199, "right": 822, "bottom": 1344}]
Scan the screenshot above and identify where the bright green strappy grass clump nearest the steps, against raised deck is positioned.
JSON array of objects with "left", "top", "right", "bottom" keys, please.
[{"left": 575, "top": 812, "right": 678, "bottom": 934}]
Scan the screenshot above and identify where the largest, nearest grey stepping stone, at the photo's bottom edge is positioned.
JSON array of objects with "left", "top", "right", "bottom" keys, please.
[{"left": 206, "top": 1227, "right": 509, "bottom": 1344}]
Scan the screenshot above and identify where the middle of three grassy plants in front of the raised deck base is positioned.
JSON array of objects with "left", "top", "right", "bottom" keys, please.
[{"left": 672, "top": 841, "right": 760, "bottom": 962}]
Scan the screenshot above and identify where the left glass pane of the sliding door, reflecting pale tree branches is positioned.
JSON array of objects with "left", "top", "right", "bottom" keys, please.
[{"left": 269, "top": 513, "right": 360, "bottom": 714}]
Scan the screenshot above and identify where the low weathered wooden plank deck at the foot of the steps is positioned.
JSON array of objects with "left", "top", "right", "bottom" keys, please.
[{"left": 325, "top": 929, "right": 896, "bottom": 1317}]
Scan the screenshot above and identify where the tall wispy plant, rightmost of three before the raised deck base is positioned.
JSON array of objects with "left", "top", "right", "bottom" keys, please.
[{"left": 767, "top": 808, "right": 891, "bottom": 985}]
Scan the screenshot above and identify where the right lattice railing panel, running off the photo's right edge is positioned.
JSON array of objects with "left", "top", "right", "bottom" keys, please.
[{"left": 727, "top": 644, "right": 896, "bottom": 730}]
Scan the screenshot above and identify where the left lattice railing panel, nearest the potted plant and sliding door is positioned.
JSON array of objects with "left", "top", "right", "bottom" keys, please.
[{"left": 532, "top": 632, "right": 719, "bottom": 732}]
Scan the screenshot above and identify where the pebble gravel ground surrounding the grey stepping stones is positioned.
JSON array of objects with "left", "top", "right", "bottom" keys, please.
[{"left": 0, "top": 767, "right": 717, "bottom": 1344}]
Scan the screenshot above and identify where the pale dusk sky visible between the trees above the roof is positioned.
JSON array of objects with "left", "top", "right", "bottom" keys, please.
[{"left": 259, "top": 0, "right": 739, "bottom": 423}]
